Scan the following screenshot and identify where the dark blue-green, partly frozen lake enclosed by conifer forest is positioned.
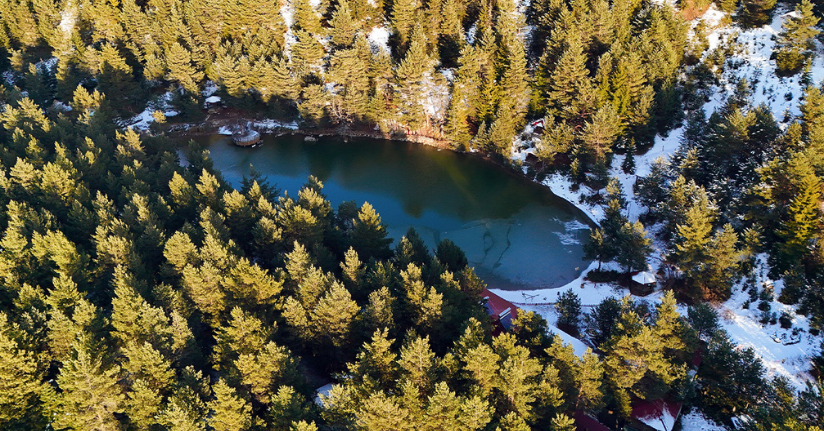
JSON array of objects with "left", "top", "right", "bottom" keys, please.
[{"left": 185, "top": 135, "right": 589, "bottom": 289}]
